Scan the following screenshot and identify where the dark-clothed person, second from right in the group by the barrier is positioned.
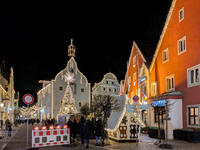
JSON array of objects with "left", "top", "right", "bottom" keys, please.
[{"left": 83, "top": 117, "right": 92, "bottom": 148}]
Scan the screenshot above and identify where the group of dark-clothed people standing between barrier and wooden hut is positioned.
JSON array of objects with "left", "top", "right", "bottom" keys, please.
[{"left": 67, "top": 116, "right": 104, "bottom": 148}]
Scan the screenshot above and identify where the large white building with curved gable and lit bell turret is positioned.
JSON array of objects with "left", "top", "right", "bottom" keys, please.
[{"left": 37, "top": 40, "right": 91, "bottom": 119}]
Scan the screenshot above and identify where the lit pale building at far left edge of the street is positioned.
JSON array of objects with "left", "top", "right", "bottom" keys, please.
[{"left": 0, "top": 61, "right": 19, "bottom": 123}]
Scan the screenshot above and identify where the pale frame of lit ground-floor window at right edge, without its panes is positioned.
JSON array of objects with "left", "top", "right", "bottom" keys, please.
[{"left": 186, "top": 105, "right": 200, "bottom": 128}]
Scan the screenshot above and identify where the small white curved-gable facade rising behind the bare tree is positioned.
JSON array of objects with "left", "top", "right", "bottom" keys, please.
[{"left": 92, "top": 72, "right": 120, "bottom": 97}]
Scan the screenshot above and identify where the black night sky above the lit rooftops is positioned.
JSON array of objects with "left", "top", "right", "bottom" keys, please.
[{"left": 0, "top": 0, "right": 172, "bottom": 105}]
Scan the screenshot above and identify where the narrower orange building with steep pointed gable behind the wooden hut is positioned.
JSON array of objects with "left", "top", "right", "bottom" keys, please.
[{"left": 124, "top": 41, "right": 149, "bottom": 124}]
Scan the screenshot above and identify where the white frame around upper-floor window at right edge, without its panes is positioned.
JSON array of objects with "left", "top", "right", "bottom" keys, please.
[{"left": 187, "top": 64, "right": 200, "bottom": 88}]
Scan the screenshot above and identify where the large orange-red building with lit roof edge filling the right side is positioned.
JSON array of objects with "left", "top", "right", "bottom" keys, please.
[{"left": 149, "top": 0, "right": 200, "bottom": 137}]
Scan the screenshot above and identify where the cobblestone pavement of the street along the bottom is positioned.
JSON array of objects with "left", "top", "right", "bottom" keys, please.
[{"left": 0, "top": 125, "right": 200, "bottom": 150}]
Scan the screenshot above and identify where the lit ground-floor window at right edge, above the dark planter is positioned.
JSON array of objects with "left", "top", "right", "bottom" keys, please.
[{"left": 187, "top": 105, "right": 200, "bottom": 127}]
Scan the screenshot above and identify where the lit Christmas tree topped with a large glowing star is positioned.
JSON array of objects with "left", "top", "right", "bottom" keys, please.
[{"left": 57, "top": 72, "right": 78, "bottom": 116}]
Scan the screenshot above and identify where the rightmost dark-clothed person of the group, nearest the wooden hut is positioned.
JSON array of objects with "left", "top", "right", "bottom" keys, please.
[{"left": 94, "top": 118, "right": 104, "bottom": 146}]
